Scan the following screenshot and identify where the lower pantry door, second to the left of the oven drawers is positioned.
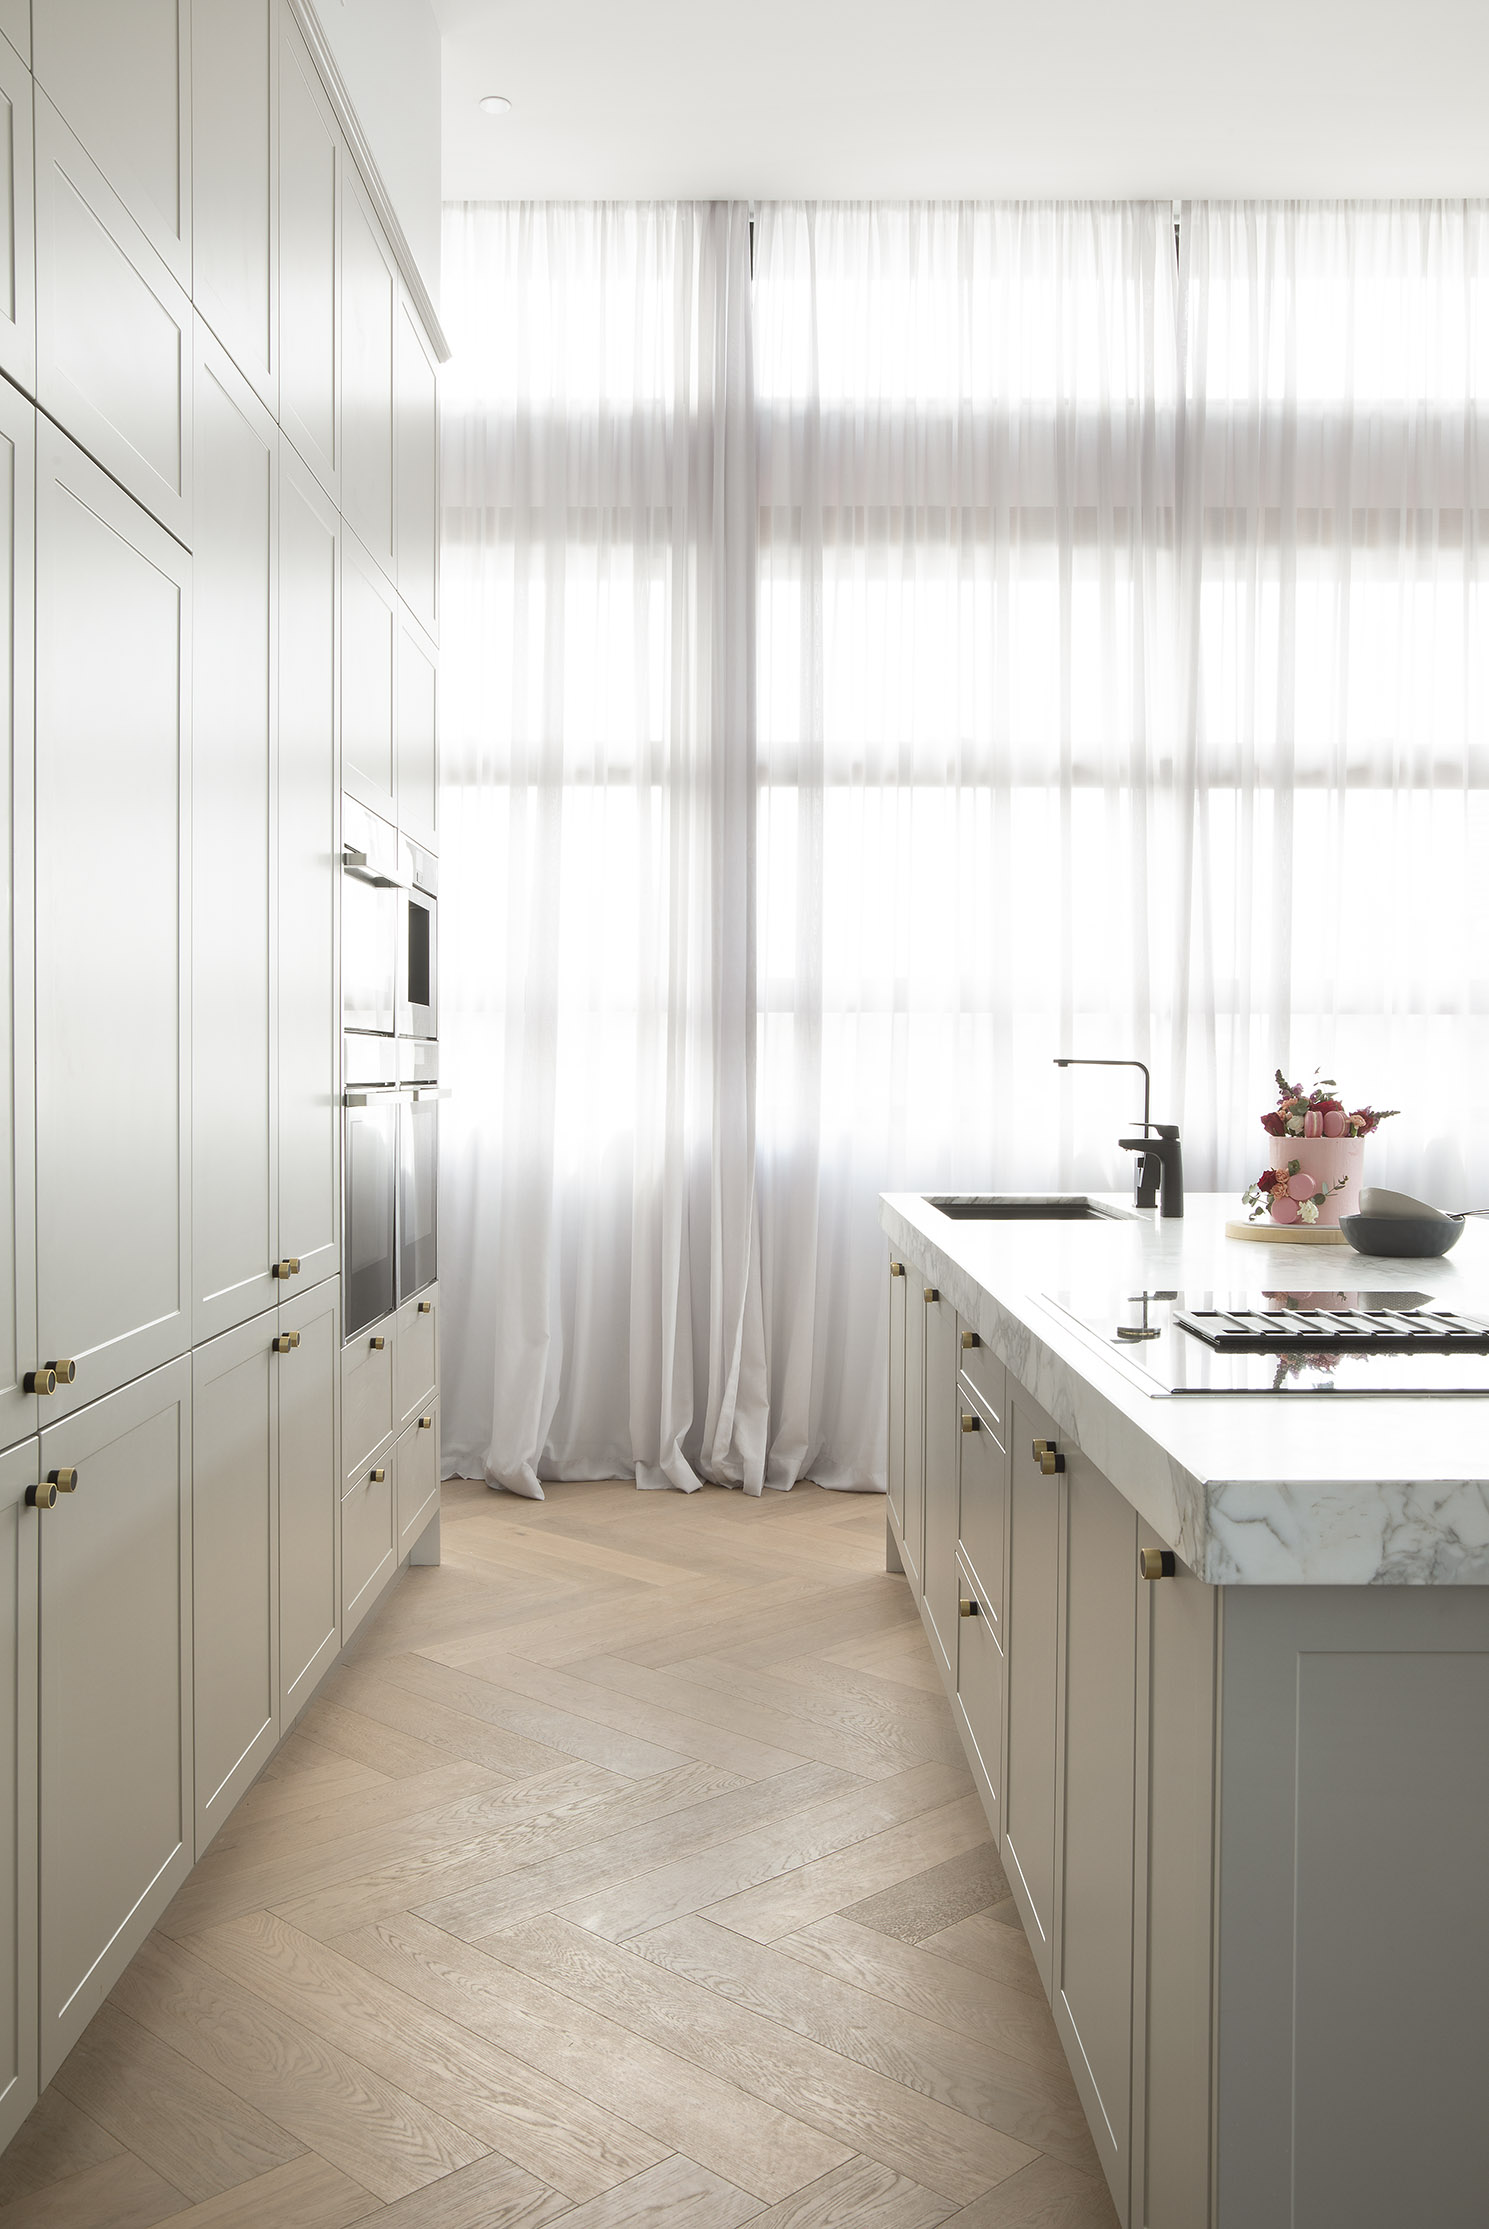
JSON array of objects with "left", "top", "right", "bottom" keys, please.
[{"left": 192, "top": 1311, "right": 276, "bottom": 1857}]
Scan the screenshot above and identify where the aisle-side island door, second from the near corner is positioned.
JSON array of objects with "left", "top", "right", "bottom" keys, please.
[{"left": 1052, "top": 1447, "right": 1139, "bottom": 2220}]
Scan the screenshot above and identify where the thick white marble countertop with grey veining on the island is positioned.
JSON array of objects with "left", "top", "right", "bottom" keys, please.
[{"left": 880, "top": 1193, "right": 1489, "bottom": 1587}]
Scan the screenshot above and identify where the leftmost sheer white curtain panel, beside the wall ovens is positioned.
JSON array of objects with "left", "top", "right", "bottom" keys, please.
[{"left": 441, "top": 207, "right": 762, "bottom": 1496}]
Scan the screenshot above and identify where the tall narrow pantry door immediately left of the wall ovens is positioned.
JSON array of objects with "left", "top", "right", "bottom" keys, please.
[{"left": 279, "top": 441, "right": 341, "bottom": 1291}]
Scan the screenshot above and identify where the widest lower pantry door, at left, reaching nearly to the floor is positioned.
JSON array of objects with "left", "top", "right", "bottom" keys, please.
[{"left": 40, "top": 1355, "right": 192, "bottom": 2082}]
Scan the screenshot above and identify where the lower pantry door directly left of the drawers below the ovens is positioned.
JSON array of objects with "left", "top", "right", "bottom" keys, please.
[{"left": 279, "top": 1277, "right": 341, "bottom": 1727}]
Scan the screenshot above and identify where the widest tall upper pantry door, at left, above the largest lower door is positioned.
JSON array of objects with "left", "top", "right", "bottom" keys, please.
[{"left": 36, "top": 421, "right": 192, "bottom": 1413}]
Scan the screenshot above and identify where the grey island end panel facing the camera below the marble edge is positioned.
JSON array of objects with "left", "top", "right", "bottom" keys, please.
[{"left": 1217, "top": 1587, "right": 1489, "bottom": 2229}]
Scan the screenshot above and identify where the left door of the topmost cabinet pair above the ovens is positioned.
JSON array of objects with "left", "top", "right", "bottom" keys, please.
[{"left": 341, "top": 163, "right": 399, "bottom": 580}]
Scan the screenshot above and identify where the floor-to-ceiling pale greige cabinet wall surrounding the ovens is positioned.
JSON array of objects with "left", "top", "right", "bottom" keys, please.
[{"left": 0, "top": 0, "right": 444, "bottom": 2144}]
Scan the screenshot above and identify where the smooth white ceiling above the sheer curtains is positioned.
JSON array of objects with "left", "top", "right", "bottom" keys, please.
[{"left": 435, "top": 0, "right": 1489, "bottom": 201}]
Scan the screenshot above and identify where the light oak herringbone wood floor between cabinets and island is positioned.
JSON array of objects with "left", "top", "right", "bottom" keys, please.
[{"left": 0, "top": 1482, "right": 1115, "bottom": 2229}]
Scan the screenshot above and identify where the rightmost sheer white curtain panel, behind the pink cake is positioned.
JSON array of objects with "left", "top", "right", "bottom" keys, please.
[{"left": 1181, "top": 203, "right": 1489, "bottom": 1208}]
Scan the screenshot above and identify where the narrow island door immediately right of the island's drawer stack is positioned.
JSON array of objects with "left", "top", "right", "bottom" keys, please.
[{"left": 1003, "top": 1395, "right": 1061, "bottom": 1997}]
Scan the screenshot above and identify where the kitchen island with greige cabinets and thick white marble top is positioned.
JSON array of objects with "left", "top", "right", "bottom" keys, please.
[{"left": 880, "top": 1195, "right": 1489, "bottom": 2229}]
